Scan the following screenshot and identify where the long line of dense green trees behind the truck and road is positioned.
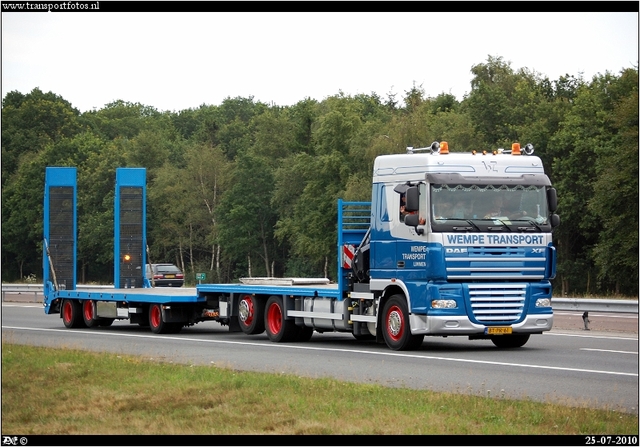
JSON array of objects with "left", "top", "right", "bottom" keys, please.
[{"left": 1, "top": 56, "right": 639, "bottom": 296}]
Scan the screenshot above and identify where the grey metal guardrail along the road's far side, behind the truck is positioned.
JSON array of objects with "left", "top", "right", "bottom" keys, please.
[{"left": 2, "top": 284, "right": 638, "bottom": 314}]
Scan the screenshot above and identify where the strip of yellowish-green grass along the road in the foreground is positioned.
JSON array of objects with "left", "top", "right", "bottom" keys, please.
[{"left": 2, "top": 342, "right": 638, "bottom": 435}]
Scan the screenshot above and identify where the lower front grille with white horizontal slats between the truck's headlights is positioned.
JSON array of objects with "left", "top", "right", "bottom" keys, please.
[{"left": 469, "top": 284, "right": 527, "bottom": 323}]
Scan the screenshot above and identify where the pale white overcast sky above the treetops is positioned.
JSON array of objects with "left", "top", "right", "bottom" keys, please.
[{"left": 2, "top": 9, "right": 638, "bottom": 112}]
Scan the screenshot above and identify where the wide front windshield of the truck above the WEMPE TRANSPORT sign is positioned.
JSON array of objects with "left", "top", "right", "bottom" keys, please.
[{"left": 430, "top": 185, "right": 549, "bottom": 225}]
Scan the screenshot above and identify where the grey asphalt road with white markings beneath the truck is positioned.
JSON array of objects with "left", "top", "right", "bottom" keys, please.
[{"left": 2, "top": 302, "right": 638, "bottom": 414}]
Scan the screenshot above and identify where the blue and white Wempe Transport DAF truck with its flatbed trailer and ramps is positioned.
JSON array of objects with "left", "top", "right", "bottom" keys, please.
[{"left": 43, "top": 141, "right": 560, "bottom": 350}]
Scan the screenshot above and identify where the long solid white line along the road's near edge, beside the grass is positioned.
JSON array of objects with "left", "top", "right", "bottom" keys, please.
[{"left": 2, "top": 326, "right": 638, "bottom": 377}]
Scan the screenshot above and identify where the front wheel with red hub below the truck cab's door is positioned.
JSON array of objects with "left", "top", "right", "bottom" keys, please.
[{"left": 382, "top": 295, "right": 424, "bottom": 351}]
